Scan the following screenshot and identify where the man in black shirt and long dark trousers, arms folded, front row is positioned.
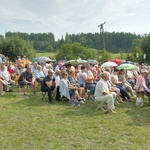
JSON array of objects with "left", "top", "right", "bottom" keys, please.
[{"left": 41, "top": 69, "right": 57, "bottom": 104}]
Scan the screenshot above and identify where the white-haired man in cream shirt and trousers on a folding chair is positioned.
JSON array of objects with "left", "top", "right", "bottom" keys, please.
[{"left": 94, "top": 72, "right": 116, "bottom": 113}]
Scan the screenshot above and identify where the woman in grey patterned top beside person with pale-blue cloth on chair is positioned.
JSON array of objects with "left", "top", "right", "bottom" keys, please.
[{"left": 68, "top": 70, "right": 85, "bottom": 99}]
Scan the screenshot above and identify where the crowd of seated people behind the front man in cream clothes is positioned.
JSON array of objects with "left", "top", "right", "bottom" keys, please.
[{"left": 0, "top": 54, "right": 150, "bottom": 110}]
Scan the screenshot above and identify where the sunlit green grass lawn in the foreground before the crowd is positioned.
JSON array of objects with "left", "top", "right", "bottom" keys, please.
[{"left": 0, "top": 89, "right": 150, "bottom": 150}]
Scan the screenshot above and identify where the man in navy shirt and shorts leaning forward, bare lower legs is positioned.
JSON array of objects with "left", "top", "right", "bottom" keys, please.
[{"left": 18, "top": 66, "right": 36, "bottom": 98}]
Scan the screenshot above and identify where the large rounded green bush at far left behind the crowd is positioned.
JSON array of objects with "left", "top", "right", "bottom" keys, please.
[{"left": 0, "top": 36, "right": 35, "bottom": 61}]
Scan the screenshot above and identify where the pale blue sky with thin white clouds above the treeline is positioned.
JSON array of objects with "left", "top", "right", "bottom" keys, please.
[{"left": 0, "top": 0, "right": 150, "bottom": 40}]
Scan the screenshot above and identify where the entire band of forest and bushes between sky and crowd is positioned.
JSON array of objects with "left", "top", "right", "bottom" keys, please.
[{"left": 0, "top": 32, "right": 150, "bottom": 62}]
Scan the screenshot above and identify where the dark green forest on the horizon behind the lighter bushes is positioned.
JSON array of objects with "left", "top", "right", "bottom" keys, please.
[{"left": 2, "top": 32, "right": 143, "bottom": 53}]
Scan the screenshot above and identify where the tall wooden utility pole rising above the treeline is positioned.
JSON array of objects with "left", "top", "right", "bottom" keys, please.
[{"left": 98, "top": 22, "right": 106, "bottom": 60}]
